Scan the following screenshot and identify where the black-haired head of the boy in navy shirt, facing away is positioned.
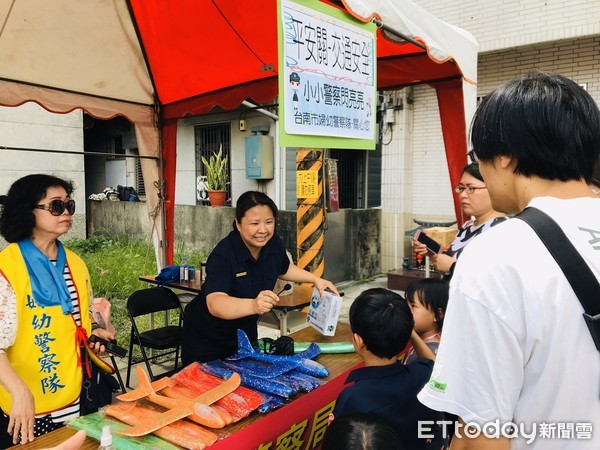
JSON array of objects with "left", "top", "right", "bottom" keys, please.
[{"left": 350, "top": 288, "right": 415, "bottom": 359}]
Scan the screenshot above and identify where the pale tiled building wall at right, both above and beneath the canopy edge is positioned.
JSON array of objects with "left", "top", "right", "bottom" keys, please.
[{"left": 382, "top": 0, "right": 600, "bottom": 272}]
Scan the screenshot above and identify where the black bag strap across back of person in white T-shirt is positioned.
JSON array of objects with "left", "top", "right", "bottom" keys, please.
[{"left": 515, "top": 207, "right": 600, "bottom": 352}]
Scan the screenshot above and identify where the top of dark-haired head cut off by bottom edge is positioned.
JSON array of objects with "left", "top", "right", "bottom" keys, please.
[{"left": 321, "top": 413, "right": 404, "bottom": 450}]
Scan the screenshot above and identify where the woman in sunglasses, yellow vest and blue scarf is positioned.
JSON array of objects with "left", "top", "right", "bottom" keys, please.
[{"left": 0, "top": 174, "right": 114, "bottom": 448}]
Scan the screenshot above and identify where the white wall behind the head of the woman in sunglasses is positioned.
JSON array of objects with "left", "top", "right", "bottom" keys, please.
[{"left": 0, "top": 103, "right": 86, "bottom": 243}]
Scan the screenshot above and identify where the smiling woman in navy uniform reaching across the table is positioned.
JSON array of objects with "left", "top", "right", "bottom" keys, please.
[{"left": 181, "top": 191, "right": 338, "bottom": 365}]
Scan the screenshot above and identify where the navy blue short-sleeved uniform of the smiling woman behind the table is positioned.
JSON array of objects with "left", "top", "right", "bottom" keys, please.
[{"left": 181, "top": 229, "right": 290, "bottom": 365}]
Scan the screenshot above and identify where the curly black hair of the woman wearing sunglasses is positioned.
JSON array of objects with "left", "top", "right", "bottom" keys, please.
[{"left": 0, "top": 173, "right": 73, "bottom": 242}]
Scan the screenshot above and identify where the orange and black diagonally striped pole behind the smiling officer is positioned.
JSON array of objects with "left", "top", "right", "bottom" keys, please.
[{"left": 296, "top": 148, "right": 325, "bottom": 277}]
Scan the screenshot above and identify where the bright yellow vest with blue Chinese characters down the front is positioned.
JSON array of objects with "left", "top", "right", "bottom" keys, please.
[{"left": 0, "top": 244, "right": 91, "bottom": 414}]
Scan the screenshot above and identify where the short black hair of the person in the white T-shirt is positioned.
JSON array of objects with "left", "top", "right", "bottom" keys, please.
[{"left": 471, "top": 71, "right": 600, "bottom": 183}]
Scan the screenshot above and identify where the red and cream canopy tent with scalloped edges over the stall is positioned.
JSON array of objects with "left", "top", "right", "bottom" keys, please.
[{"left": 0, "top": 0, "right": 477, "bottom": 264}]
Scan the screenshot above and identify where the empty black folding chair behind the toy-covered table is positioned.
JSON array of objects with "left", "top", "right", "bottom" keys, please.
[{"left": 126, "top": 287, "right": 183, "bottom": 388}]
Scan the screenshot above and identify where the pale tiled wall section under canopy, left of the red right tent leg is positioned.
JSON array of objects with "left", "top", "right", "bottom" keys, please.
[{"left": 381, "top": 85, "right": 455, "bottom": 272}]
